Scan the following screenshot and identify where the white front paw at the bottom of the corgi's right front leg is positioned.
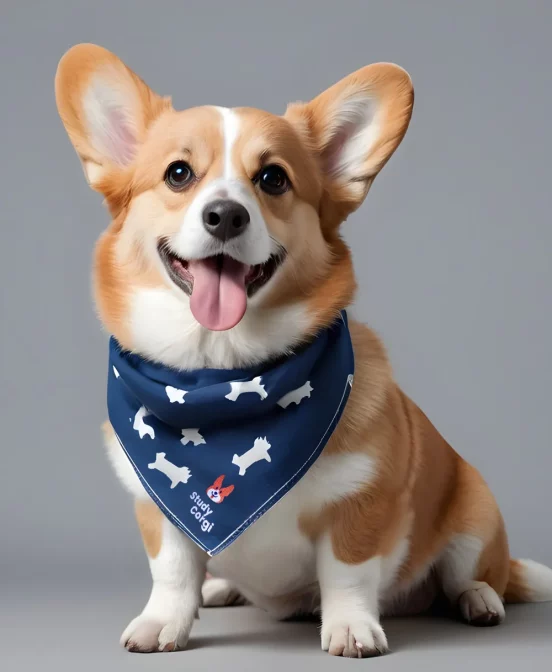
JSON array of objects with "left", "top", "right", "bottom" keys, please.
[{"left": 322, "top": 615, "right": 389, "bottom": 658}]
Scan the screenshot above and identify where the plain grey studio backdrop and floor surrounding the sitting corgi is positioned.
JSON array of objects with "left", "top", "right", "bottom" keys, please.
[{"left": 0, "top": 0, "right": 552, "bottom": 670}]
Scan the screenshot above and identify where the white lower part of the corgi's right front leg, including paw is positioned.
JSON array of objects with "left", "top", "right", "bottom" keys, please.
[{"left": 317, "top": 535, "right": 387, "bottom": 658}]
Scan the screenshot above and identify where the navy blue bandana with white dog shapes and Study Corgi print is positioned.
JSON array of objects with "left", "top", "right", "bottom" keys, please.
[{"left": 107, "top": 313, "right": 354, "bottom": 555}]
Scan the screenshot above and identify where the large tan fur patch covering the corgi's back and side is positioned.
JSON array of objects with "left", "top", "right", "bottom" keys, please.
[{"left": 301, "top": 322, "right": 509, "bottom": 595}]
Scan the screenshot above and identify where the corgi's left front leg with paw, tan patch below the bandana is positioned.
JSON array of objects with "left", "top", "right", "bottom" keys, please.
[{"left": 121, "top": 500, "right": 208, "bottom": 653}]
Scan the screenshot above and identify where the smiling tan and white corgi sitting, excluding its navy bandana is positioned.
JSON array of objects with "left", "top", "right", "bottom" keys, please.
[{"left": 55, "top": 44, "right": 552, "bottom": 658}]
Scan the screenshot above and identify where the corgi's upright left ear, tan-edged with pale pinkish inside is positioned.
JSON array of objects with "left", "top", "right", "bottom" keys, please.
[{"left": 55, "top": 44, "right": 171, "bottom": 191}]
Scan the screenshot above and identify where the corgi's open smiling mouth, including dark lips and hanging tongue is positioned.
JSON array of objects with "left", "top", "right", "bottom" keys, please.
[{"left": 158, "top": 239, "right": 285, "bottom": 331}]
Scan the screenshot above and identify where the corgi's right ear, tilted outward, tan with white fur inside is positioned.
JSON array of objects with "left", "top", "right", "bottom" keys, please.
[{"left": 285, "top": 63, "right": 414, "bottom": 219}]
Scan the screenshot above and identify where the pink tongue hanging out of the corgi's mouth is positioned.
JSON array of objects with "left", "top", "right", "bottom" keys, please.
[{"left": 188, "top": 256, "right": 249, "bottom": 331}]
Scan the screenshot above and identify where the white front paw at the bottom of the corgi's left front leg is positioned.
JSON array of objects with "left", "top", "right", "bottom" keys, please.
[{"left": 121, "top": 614, "right": 190, "bottom": 653}]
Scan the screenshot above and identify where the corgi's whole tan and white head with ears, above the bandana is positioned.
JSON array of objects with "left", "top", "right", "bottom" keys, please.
[{"left": 56, "top": 44, "right": 413, "bottom": 368}]
